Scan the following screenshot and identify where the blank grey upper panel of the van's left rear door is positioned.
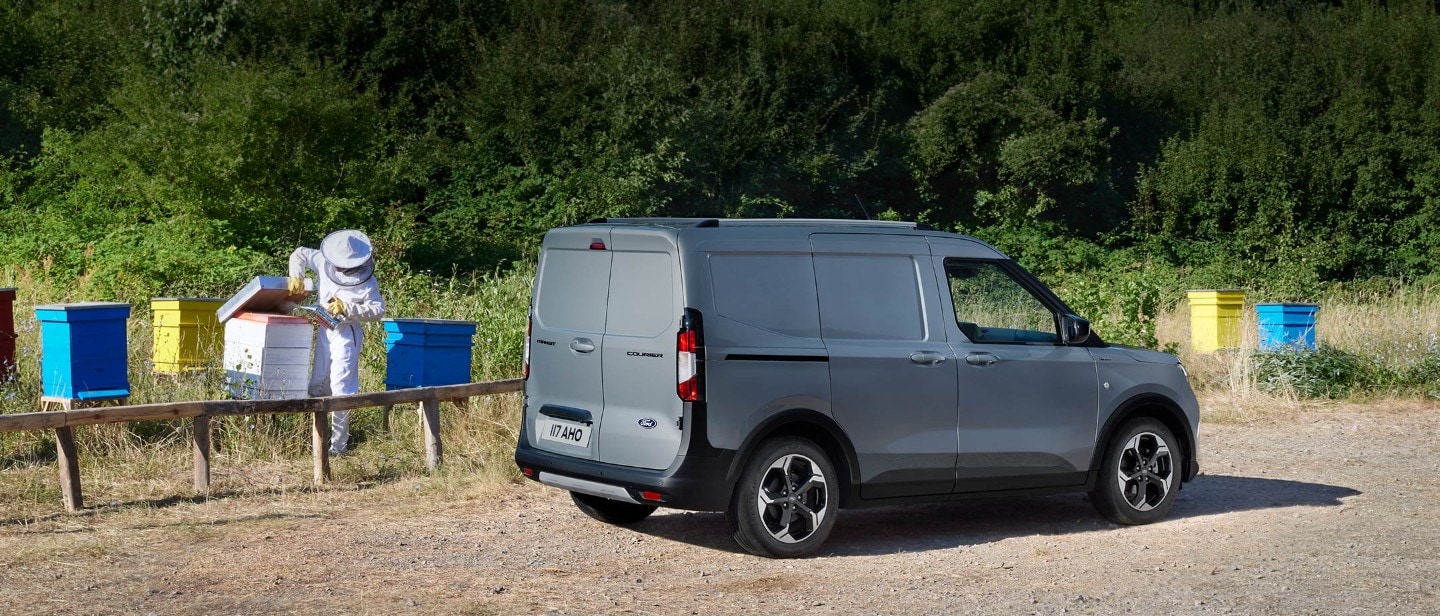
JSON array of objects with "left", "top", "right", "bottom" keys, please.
[{"left": 536, "top": 248, "right": 611, "bottom": 334}]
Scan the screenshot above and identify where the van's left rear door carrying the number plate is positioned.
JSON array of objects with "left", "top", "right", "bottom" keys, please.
[{"left": 524, "top": 227, "right": 612, "bottom": 459}]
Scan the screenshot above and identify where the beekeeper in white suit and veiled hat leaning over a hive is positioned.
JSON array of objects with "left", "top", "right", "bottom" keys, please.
[{"left": 288, "top": 229, "right": 384, "bottom": 455}]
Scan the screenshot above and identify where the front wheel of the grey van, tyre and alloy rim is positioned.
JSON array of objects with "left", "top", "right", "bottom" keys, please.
[{"left": 1090, "top": 417, "right": 1185, "bottom": 525}]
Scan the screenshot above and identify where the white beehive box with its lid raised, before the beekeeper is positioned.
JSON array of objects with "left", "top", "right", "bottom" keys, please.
[{"left": 223, "top": 312, "right": 312, "bottom": 400}]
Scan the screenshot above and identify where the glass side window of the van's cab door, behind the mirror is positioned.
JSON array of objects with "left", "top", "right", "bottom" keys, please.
[{"left": 945, "top": 259, "right": 1060, "bottom": 344}]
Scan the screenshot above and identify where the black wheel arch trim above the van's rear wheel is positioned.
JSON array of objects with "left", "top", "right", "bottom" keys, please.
[{"left": 726, "top": 409, "right": 860, "bottom": 508}]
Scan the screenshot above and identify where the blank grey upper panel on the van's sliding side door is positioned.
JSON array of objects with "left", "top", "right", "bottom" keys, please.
[{"left": 815, "top": 255, "right": 924, "bottom": 340}]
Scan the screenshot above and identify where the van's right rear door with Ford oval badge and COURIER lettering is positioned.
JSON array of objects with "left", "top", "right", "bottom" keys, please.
[{"left": 598, "top": 227, "right": 684, "bottom": 469}]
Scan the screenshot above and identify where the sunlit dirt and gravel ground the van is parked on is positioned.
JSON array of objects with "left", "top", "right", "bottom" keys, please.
[{"left": 0, "top": 406, "right": 1440, "bottom": 615}]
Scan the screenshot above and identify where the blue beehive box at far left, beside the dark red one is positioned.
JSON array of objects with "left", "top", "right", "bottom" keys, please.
[{"left": 35, "top": 302, "right": 130, "bottom": 400}]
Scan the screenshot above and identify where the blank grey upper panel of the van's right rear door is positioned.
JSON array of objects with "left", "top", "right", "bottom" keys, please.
[{"left": 605, "top": 250, "right": 680, "bottom": 338}]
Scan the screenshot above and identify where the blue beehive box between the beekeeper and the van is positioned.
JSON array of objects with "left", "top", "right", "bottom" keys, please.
[{"left": 382, "top": 318, "right": 475, "bottom": 389}]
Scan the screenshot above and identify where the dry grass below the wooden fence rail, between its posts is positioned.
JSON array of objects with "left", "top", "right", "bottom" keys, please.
[{"left": 0, "top": 394, "right": 520, "bottom": 524}]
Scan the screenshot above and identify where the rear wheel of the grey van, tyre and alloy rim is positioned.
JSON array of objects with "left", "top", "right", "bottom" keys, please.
[{"left": 726, "top": 438, "right": 840, "bottom": 558}]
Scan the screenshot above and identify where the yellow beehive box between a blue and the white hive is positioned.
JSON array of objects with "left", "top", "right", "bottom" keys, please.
[{"left": 150, "top": 298, "right": 225, "bottom": 373}]
